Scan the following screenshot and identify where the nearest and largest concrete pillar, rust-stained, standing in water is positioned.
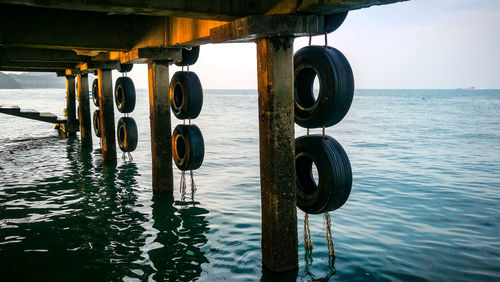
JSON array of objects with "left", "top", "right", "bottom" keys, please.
[{"left": 257, "top": 37, "right": 298, "bottom": 272}]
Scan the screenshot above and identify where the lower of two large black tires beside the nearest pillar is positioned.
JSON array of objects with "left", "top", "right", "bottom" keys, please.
[{"left": 295, "top": 135, "right": 352, "bottom": 214}]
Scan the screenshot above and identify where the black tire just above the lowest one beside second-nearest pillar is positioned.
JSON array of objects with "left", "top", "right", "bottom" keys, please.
[{"left": 170, "top": 71, "right": 203, "bottom": 119}]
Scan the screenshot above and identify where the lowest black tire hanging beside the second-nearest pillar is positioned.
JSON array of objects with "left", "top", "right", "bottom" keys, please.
[{"left": 172, "top": 124, "right": 205, "bottom": 171}]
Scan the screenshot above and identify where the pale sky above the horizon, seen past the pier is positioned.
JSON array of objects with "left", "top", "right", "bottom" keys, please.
[{"left": 121, "top": 0, "right": 500, "bottom": 89}]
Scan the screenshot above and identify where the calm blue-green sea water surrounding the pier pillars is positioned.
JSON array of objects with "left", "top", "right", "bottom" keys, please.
[{"left": 0, "top": 89, "right": 500, "bottom": 281}]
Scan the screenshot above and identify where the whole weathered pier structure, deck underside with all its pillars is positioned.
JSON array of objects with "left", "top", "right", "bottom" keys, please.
[{"left": 0, "top": 0, "right": 401, "bottom": 272}]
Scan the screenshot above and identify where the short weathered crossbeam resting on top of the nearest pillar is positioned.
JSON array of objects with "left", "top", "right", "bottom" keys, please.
[{"left": 210, "top": 15, "right": 324, "bottom": 43}]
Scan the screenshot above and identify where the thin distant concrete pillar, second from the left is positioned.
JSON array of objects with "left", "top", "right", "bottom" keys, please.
[{"left": 76, "top": 74, "right": 92, "bottom": 148}]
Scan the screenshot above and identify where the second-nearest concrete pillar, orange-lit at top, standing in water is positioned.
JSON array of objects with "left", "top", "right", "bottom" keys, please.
[{"left": 148, "top": 62, "right": 174, "bottom": 193}]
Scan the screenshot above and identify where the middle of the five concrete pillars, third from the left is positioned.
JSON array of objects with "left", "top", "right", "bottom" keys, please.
[{"left": 97, "top": 69, "right": 116, "bottom": 163}]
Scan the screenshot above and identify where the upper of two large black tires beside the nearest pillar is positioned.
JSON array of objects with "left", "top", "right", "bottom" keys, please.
[{"left": 294, "top": 46, "right": 354, "bottom": 128}]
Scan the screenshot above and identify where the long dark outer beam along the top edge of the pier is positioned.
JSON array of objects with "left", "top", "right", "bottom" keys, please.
[{"left": 0, "top": 0, "right": 404, "bottom": 21}]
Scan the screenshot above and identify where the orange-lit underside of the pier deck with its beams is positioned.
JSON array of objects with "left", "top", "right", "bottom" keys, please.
[{"left": 0, "top": 0, "right": 401, "bottom": 68}]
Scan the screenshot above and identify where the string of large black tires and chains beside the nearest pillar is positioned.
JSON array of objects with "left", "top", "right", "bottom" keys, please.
[{"left": 294, "top": 17, "right": 354, "bottom": 266}]
